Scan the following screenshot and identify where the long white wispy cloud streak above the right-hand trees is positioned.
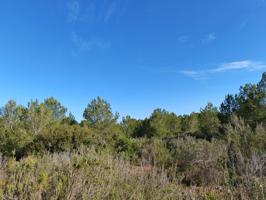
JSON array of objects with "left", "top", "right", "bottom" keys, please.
[{"left": 179, "top": 60, "right": 266, "bottom": 80}]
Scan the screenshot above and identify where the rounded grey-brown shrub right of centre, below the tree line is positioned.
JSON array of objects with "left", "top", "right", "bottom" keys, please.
[{"left": 167, "top": 138, "right": 227, "bottom": 185}]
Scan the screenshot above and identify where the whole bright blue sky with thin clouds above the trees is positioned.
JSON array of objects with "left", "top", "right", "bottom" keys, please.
[{"left": 0, "top": 0, "right": 266, "bottom": 120}]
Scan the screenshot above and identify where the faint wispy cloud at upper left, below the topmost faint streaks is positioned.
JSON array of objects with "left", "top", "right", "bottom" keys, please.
[{"left": 71, "top": 32, "right": 110, "bottom": 51}]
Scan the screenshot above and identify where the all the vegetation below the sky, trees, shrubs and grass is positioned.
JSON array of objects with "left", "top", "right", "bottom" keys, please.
[{"left": 0, "top": 72, "right": 266, "bottom": 200}]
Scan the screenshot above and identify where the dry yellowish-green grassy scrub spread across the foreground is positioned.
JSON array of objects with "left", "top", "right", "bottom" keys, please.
[{"left": 0, "top": 149, "right": 265, "bottom": 200}]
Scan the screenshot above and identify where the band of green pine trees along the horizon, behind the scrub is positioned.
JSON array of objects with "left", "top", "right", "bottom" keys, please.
[{"left": 0, "top": 73, "right": 266, "bottom": 158}]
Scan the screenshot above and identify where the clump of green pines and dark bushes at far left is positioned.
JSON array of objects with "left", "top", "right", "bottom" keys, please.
[{"left": 0, "top": 98, "right": 91, "bottom": 159}]
